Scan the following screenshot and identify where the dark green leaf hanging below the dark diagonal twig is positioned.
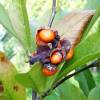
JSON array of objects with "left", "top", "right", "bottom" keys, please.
[{"left": 75, "top": 69, "right": 96, "bottom": 96}]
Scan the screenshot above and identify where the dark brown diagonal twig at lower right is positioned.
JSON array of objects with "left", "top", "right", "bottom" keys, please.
[{"left": 42, "top": 62, "right": 96, "bottom": 98}]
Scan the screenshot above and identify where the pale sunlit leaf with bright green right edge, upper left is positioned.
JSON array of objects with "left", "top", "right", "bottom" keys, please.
[{"left": 7, "top": 0, "right": 32, "bottom": 51}]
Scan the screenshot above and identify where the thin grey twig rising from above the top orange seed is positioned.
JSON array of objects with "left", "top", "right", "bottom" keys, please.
[{"left": 48, "top": 0, "right": 56, "bottom": 28}]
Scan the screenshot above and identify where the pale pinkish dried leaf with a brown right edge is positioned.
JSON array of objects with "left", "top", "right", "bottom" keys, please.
[{"left": 53, "top": 10, "right": 94, "bottom": 46}]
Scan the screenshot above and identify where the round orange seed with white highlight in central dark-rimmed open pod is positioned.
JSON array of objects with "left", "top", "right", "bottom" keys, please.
[{"left": 50, "top": 49, "right": 63, "bottom": 64}]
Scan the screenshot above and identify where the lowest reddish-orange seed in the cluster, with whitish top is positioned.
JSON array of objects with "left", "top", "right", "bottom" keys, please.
[{"left": 42, "top": 66, "right": 57, "bottom": 76}]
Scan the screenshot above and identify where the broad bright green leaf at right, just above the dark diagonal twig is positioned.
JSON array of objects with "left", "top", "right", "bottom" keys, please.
[{"left": 57, "top": 30, "right": 100, "bottom": 79}]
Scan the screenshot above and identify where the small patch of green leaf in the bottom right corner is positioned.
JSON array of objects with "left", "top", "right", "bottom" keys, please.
[{"left": 88, "top": 85, "right": 100, "bottom": 100}]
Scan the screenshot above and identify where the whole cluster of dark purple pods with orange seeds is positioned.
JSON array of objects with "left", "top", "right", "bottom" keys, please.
[{"left": 29, "top": 28, "right": 71, "bottom": 76}]
